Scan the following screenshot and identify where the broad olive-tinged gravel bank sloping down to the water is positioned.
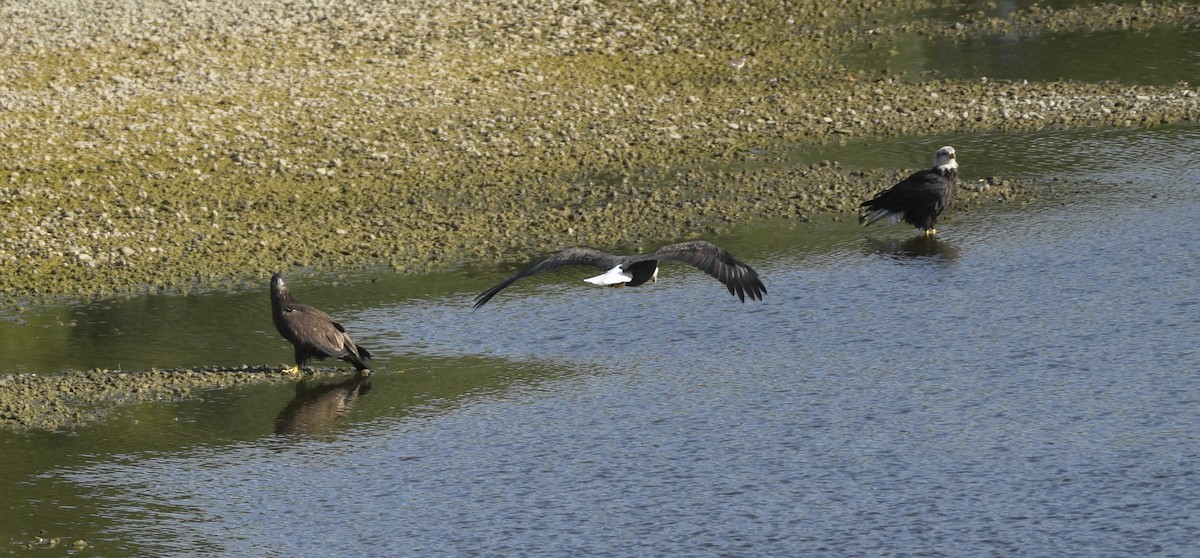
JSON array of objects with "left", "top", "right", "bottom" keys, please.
[{"left": 0, "top": 0, "right": 1200, "bottom": 425}]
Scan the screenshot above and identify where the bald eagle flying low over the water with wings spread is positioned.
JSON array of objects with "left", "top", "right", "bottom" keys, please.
[{"left": 475, "top": 240, "right": 767, "bottom": 308}]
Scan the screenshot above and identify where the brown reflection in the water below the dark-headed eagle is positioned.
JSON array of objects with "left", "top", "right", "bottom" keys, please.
[{"left": 275, "top": 373, "right": 371, "bottom": 434}]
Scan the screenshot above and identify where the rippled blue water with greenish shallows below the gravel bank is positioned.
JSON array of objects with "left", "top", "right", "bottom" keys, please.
[{"left": 0, "top": 126, "right": 1200, "bottom": 557}]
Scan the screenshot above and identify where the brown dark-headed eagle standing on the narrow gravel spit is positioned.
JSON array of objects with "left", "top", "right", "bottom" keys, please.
[{"left": 271, "top": 274, "right": 371, "bottom": 374}]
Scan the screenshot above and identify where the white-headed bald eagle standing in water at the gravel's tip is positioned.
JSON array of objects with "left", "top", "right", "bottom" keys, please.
[{"left": 859, "top": 145, "right": 959, "bottom": 236}]
